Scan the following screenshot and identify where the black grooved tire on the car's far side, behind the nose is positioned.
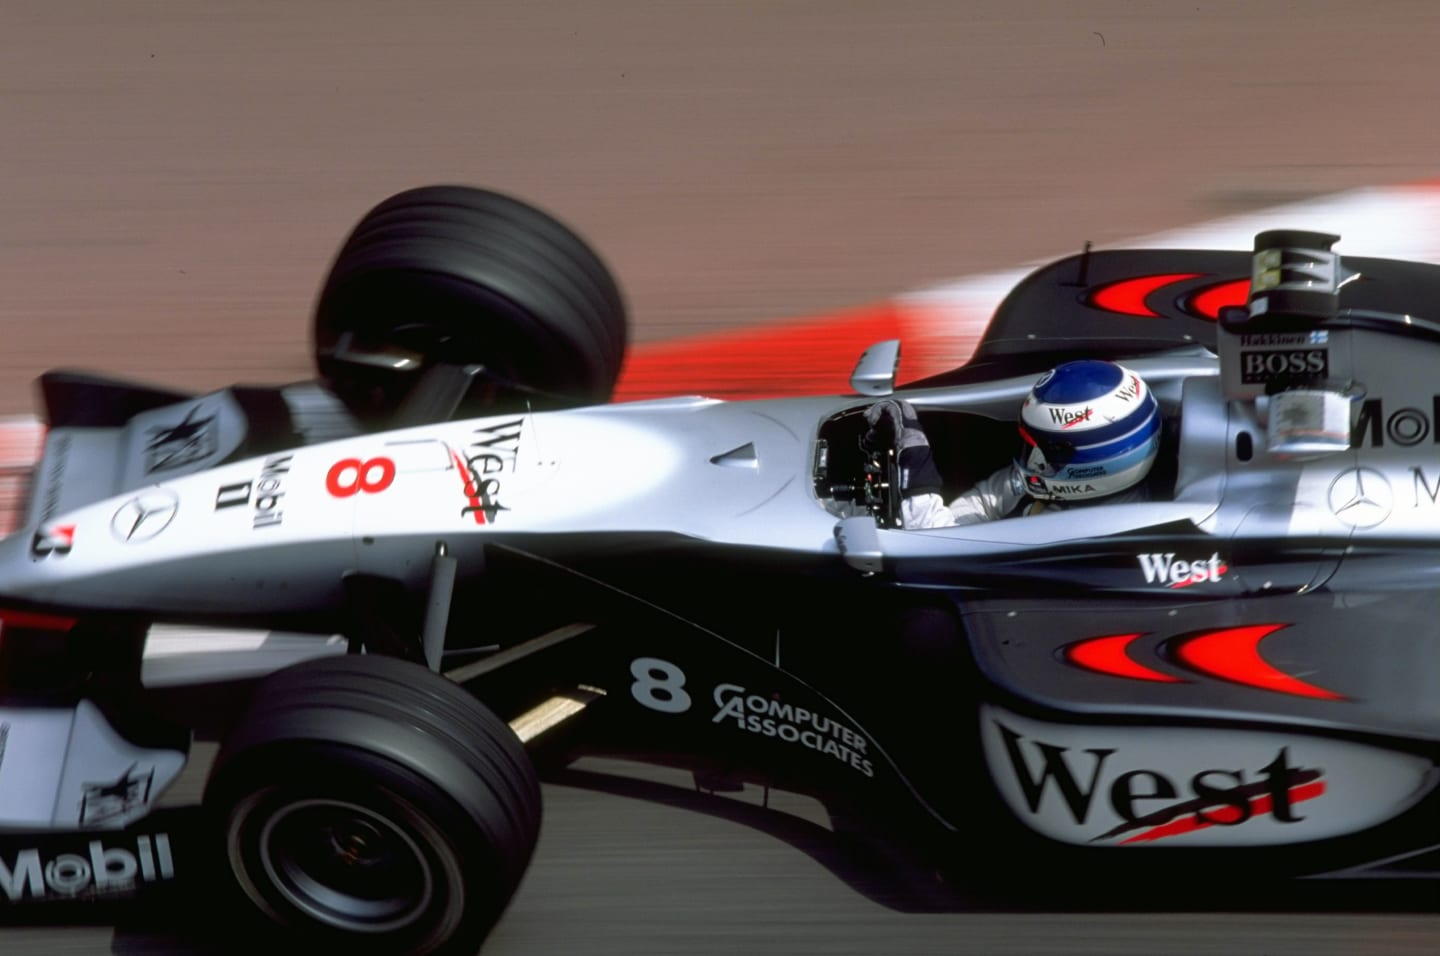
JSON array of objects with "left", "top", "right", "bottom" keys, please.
[{"left": 314, "top": 186, "right": 628, "bottom": 416}]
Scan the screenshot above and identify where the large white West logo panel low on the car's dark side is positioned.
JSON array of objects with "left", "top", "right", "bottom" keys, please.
[{"left": 979, "top": 704, "right": 1436, "bottom": 847}]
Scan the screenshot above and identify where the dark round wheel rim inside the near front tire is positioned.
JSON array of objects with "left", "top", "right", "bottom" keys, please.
[{"left": 258, "top": 799, "right": 435, "bottom": 933}]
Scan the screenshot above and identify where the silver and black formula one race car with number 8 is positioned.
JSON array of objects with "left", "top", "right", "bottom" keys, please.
[{"left": 0, "top": 187, "right": 1440, "bottom": 953}]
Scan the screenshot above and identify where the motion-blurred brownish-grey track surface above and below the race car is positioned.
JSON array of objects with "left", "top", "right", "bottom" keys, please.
[{"left": 0, "top": 0, "right": 1440, "bottom": 956}]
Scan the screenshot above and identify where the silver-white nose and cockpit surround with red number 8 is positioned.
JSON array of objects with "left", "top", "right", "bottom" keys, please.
[{"left": 0, "top": 354, "right": 1223, "bottom": 616}]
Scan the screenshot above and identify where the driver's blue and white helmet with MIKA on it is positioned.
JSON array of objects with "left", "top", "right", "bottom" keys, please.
[{"left": 1015, "top": 359, "right": 1161, "bottom": 501}]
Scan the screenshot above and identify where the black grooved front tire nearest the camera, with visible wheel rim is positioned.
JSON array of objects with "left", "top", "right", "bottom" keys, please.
[{"left": 204, "top": 655, "right": 540, "bottom": 955}]
